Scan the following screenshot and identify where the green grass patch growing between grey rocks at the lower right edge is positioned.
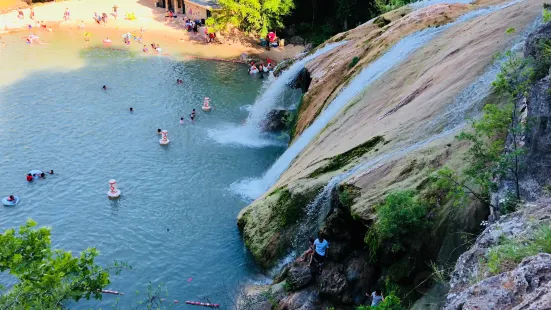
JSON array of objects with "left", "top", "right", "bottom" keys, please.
[{"left": 486, "top": 226, "right": 551, "bottom": 275}]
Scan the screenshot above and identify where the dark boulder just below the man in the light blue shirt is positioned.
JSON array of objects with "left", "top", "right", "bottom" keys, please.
[{"left": 318, "top": 263, "right": 352, "bottom": 303}]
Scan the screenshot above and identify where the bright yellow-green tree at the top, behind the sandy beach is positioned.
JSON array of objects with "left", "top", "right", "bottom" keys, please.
[{"left": 207, "top": 0, "right": 295, "bottom": 37}]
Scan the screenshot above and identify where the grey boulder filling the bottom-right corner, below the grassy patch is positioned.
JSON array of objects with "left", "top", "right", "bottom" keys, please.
[{"left": 444, "top": 254, "right": 551, "bottom": 310}]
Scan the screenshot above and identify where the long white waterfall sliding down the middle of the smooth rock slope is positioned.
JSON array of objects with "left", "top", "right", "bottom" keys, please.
[{"left": 232, "top": 0, "right": 520, "bottom": 199}]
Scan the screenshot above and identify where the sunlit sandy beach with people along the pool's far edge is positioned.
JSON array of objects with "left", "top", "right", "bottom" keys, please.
[{"left": 0, "top": 0, "right": 304, "bottom": 61}]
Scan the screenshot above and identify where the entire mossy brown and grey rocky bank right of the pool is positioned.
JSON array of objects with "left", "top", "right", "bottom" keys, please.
[{"left": 238, "top": 0, "right": 551, "bottom": 309}]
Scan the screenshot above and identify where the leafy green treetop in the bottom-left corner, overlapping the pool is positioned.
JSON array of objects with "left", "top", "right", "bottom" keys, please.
[{"left": 0, "top": 220, "right": 127, "bottom": 309}]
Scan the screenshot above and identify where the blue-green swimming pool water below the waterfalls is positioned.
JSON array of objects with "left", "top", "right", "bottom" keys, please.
[{"left": 0, "top": 36, "right": 283, "bottom": 308}]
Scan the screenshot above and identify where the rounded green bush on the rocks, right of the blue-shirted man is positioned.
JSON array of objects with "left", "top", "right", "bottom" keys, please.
[{"left": 365, "top": 191, "right": 429, "bottom": 259}]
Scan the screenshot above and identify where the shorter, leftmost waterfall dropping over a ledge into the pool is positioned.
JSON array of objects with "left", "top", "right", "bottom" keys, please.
[{"left": 208, "top": 41, "right": 346, "bottom": 147}]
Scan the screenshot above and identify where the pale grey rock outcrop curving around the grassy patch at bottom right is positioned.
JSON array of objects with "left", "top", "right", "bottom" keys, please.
[{"left": 444, "top": 199, "right": 551, "bottom": 310}]
